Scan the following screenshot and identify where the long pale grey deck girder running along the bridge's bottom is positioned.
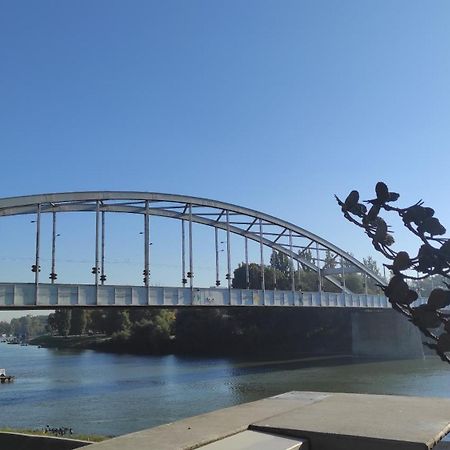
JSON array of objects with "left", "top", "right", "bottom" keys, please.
[{"left": 0, "top": 283, "right": 390, "bottom": 309}]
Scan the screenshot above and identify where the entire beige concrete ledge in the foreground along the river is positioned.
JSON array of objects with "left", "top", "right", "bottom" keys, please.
[{"left": 90, "top": 392, "right": 450, "bottom": 450}]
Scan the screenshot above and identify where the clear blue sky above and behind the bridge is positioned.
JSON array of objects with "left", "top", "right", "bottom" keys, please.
[{"left": 0, "top": 0, "right": 450, "bottom": 320}]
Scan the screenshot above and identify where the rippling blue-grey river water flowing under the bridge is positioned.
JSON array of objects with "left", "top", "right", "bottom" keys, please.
[{"left": 0, "top": 343, "right": 450, "bottom": 436}]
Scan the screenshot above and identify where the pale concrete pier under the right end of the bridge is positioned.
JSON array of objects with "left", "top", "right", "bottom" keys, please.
[{"left": 351, "top": 309, "right": 424, "bottom": 359}]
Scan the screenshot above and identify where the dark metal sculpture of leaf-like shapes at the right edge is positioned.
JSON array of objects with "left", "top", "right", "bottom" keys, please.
[{"left": 335, "top": 182, "right": 450, "bottom": 363}]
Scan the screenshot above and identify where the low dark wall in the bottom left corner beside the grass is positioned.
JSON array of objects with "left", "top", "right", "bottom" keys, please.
[{"left": 0, "top": 432, "right": 92, "bottom": 450}]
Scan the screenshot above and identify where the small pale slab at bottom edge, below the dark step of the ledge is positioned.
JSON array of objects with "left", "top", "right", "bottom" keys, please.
[{"left": 199, "top": 431, "right": 308, "bottom": 450}]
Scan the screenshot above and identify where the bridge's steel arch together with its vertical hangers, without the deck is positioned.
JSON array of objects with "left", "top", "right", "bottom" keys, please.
[{"left": 0, "top": 191, "right": 383, "bottom": 307}]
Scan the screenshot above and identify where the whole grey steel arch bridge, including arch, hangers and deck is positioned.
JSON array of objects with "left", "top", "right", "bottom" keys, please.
[{"left": 0, "top": 191, "right": 388, "bottom": 309}]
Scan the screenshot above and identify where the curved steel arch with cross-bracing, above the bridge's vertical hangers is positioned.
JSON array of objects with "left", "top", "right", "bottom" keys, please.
[{"left": 0, "top": 191, "right": 384, "bottom": 292}]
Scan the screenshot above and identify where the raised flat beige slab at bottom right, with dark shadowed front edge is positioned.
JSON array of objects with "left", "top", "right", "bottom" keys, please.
[{"left": 250, "top": 393, "right": 450, "bottom": 450}]
